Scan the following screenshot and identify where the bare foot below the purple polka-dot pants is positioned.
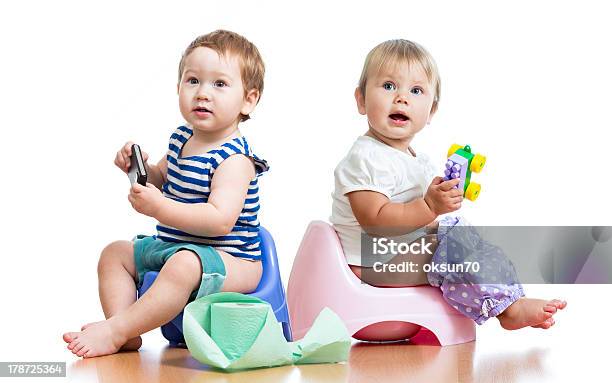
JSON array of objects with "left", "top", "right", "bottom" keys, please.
[{"left": 497, "top": 297, "right": 567, "bottom": 330}]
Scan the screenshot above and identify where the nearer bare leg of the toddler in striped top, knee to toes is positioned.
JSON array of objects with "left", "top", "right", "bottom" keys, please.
[{"left": 64, "top": 251, "right": 202, "bottom": 357}]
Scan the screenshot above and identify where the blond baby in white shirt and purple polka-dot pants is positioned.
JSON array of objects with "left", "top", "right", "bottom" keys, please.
[{"left": 330, "top": 40, "right": 566, "bottom": 330}]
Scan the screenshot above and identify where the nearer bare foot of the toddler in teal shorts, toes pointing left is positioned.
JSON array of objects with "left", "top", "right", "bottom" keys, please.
[{"left": 64, "top": 319, "right": 127, "bottom": 358}]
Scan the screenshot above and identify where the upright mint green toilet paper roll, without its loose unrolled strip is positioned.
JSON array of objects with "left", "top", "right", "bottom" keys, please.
[{"left": 210, "top": 302, "right": 270, "bottom": 360}]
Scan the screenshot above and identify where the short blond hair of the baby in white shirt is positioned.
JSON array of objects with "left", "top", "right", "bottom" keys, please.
[{"left": 359, "top": 39, "right": 440, "bottom": 112}]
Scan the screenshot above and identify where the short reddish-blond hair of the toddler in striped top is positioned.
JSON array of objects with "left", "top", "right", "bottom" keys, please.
[{"left": 178, "top": 29, "right": 265, "bottom": 121}]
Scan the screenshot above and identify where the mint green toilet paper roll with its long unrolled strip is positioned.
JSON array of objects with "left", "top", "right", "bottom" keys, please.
[{"left": 183, "top": 293, "right": 351, "bottom": 371}]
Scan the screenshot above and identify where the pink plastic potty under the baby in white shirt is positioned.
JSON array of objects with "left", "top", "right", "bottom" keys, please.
[{"left": 287, "top": 221, "right": 476, "bottom": 346}]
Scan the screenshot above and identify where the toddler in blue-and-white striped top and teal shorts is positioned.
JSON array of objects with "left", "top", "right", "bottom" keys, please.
[{"left": 63, "top": 30, "right": 268, "bottom": 358}]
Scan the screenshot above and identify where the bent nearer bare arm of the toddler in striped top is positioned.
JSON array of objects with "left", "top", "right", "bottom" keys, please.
[{"left": 154, "top": 155, "right": 255, "bottom": 236}]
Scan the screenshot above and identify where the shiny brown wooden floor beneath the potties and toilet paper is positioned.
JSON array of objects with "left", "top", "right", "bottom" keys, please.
[{"left": 63, "top": 336, "right": 584, "bottom": 382}]
